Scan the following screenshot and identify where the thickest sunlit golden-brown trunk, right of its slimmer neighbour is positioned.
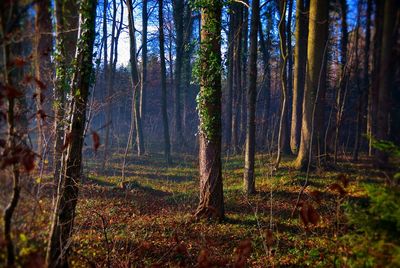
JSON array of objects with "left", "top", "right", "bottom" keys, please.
[{"left": 295, "top": 0, "right": 329, "bottom": 169}]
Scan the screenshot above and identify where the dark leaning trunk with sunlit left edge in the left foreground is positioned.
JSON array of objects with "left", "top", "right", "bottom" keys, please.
[{"left": 46, "top": 0, "right": 96, "bottom": 267}]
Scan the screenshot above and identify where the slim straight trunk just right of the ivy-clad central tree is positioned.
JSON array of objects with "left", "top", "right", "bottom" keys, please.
[{"left": 243, "top": 0, "right": 260, "bottom": 194}]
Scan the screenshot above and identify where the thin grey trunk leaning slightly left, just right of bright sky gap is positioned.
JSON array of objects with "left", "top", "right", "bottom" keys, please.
[{"left": 127, "top": 0, "right": 144, "bottom": 156}]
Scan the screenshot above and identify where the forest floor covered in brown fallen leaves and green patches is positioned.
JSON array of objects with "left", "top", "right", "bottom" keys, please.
[{"left": 0, "top": 154, "right": 384, "bottom": 267}]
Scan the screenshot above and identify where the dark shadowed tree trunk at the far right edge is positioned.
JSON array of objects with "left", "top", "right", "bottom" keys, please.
[{"left": 376, "top": 0, "right": 399, "bottom": 167}]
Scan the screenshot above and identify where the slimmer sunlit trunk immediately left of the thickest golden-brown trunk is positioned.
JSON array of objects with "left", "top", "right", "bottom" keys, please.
[{"left": 290, "top": 0, "right": 309, "bottom": 154}]
